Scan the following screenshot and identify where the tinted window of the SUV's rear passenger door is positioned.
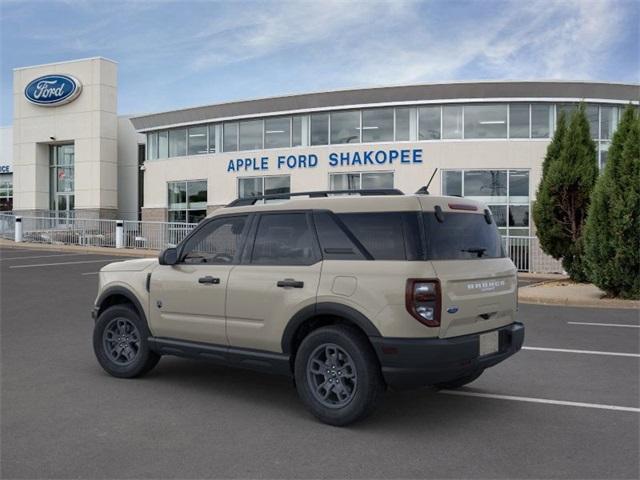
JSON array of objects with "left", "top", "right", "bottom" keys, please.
[{"left": 251, "top": 213, "right": 320, "bottom": 265}]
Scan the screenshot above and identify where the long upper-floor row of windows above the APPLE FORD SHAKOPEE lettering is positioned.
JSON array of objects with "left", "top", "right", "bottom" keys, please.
[{"left": 147, "top": 102, "right": 622, "bottom": 163}]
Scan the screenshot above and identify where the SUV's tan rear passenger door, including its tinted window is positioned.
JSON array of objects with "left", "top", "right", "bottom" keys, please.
[{"left": 227, "top": 212, "right": 322, "bottom": 352}]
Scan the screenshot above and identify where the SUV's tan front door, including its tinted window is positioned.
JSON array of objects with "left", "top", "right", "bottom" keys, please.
[{"left": 149, "top": 215, "right": 249, "bottom": 345}]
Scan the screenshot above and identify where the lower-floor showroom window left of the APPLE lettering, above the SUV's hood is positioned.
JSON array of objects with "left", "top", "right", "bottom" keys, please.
[{"left": 167, "top": 180, "right": 207, "bottom": 223}]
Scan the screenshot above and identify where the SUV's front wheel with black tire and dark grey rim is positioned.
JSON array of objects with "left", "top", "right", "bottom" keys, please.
[{"left": 93, "top": 305, "right": 160, "bottom": 378}]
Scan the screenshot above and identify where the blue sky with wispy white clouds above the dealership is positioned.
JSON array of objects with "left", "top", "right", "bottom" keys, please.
[{"left": 0, "top": 0, "right": 640, "bottom": 125}]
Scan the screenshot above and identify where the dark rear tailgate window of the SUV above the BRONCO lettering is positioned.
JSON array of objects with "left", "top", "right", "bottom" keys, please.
[{"left": 423, "top": 212, "right": 505, "bottom": 260}]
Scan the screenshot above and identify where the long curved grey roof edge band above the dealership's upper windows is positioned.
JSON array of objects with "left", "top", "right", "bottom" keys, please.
[{"left": 131, "top": 80, "right": 640, "bottom": 130}]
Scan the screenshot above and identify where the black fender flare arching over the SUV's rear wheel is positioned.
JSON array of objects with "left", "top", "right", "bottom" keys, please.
[{"left": 281, "top": 302, "right": 382, "bottom": 353}]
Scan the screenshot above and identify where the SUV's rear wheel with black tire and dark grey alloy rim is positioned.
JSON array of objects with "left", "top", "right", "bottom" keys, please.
[{"left": 295, "top": 325, "right": 384, "bottom": 426}]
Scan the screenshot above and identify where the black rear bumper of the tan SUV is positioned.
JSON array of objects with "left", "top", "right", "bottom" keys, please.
[{"left": 369, "top": 322, "right": 524, "bottom": 389}]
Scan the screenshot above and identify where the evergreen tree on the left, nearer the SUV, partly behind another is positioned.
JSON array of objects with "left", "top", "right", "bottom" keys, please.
[{"left": 533, "top": 105, "right": 598, "bottom": 282}]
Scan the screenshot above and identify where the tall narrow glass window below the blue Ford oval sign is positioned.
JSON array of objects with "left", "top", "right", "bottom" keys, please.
[{"left": 49, "top": 144, "right": 75, "bottom": 218}]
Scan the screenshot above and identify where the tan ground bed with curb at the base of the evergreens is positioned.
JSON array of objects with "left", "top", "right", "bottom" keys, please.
[{"left": 518, "top": 275, "right": 640, "bottom": 310}]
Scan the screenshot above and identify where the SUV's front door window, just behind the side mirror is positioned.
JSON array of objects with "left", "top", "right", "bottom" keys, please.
[{"left": 182, "top": 215, "right": 248, "bottom": 265}]
